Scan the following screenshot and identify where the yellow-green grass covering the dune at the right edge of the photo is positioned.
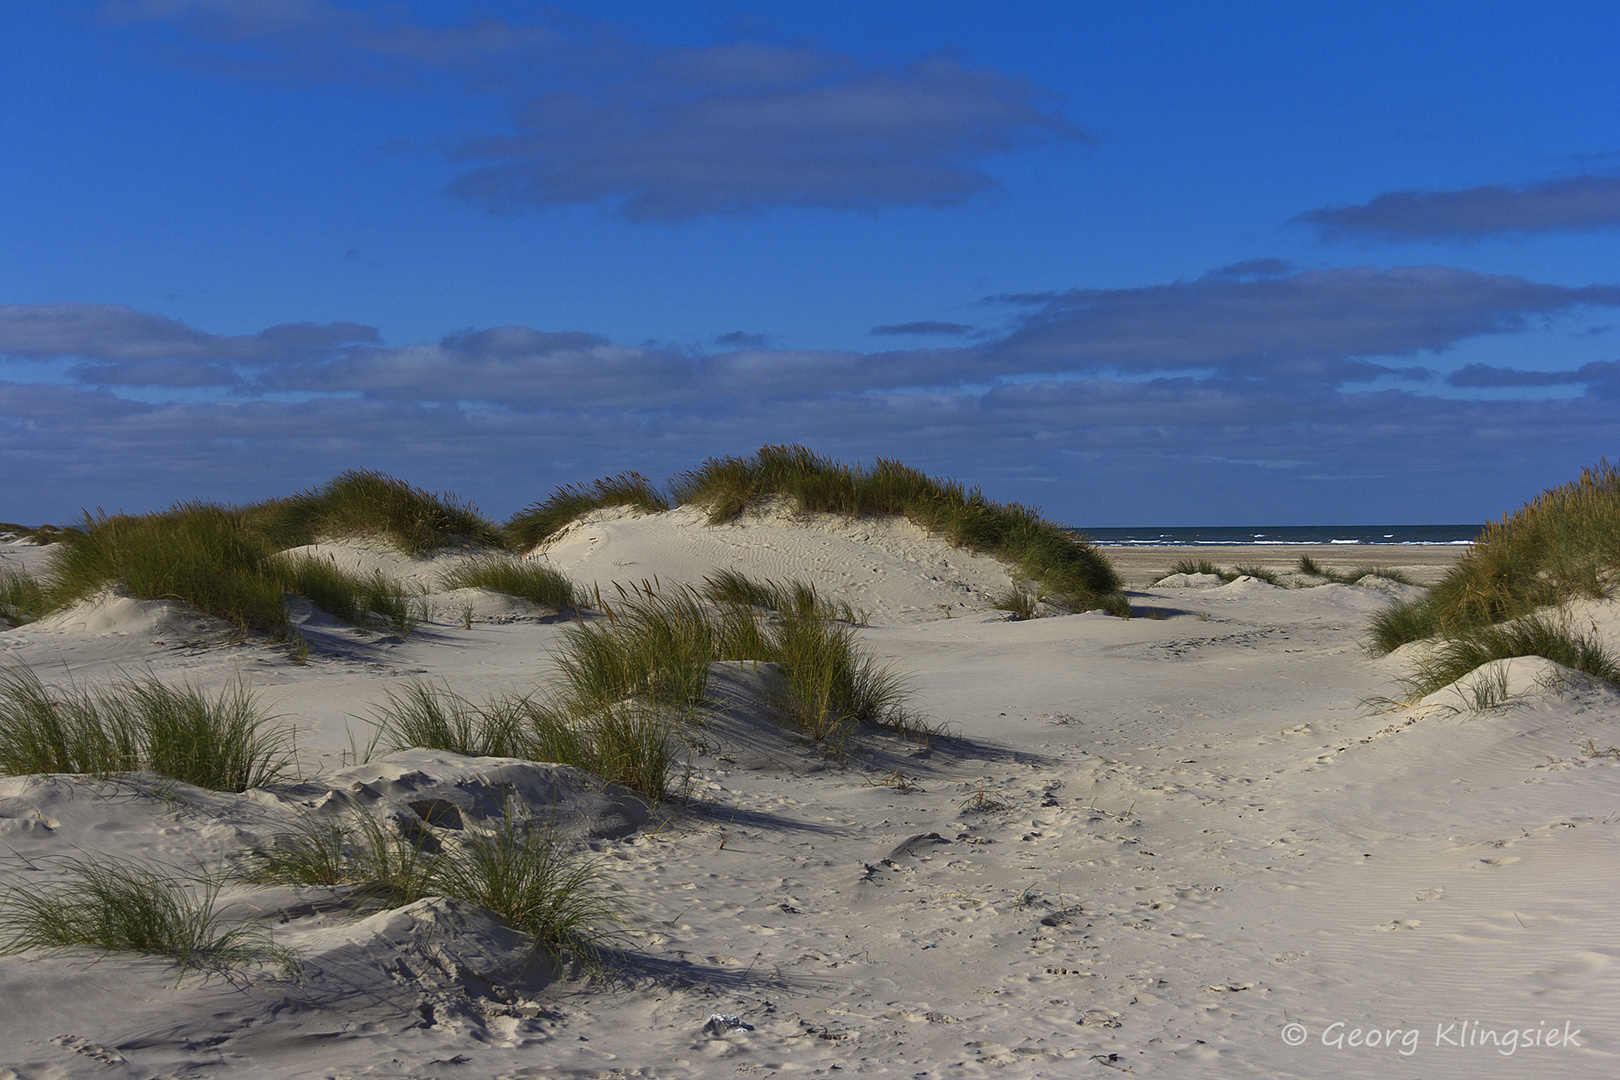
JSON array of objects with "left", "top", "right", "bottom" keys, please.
[{"left": 1367, "top": 461, "right": 1620, "bottom": 696}]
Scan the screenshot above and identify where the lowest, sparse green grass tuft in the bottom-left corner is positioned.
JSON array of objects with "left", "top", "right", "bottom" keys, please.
[{"left": 0, "top": 858, "right": 293, "bottom": 972}]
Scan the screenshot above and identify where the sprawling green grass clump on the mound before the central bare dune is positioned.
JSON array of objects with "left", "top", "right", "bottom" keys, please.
[{"left": 373, "top": 573, "right": 932, "bottom": 800}]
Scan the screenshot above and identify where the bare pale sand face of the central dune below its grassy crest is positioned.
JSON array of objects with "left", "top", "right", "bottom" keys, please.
[{"left": 535, "top": 500, "right": 1013, "bottom": 625}]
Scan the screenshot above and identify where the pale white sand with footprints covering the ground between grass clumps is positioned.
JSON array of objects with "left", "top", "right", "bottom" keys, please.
[{"left": 0, "top": 513, "right": 1620, "bottom": 1078}]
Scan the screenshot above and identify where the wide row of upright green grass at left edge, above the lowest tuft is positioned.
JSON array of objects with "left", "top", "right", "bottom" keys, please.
[{"left": 0, "top": 667, "right": 292, "bottom": 792}]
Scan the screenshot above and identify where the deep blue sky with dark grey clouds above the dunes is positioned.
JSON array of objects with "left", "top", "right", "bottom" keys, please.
[{"left": 0, "top": 0, "right": 1620, "bottom": 526}]
